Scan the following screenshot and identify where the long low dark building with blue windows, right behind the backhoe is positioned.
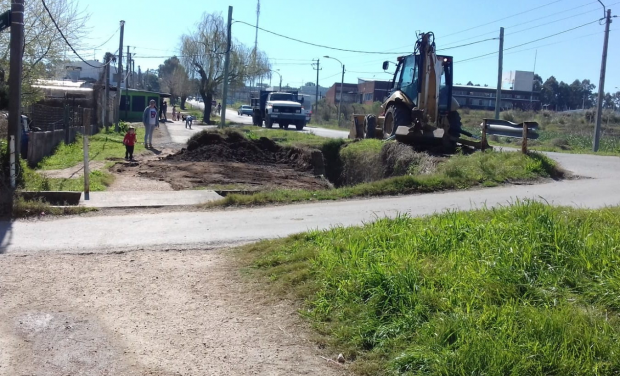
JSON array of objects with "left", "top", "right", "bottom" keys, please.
[{"left": 452, "top": 85, "right": 540, "bottom": 111}]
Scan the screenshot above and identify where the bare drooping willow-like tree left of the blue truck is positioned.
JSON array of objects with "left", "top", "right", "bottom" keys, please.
[{"left": 181, "top": 13, "right": 271, "bottom": 123}]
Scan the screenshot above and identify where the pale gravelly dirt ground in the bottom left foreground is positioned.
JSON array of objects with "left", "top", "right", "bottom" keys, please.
[{"left": 0, "top": 248, "right": 344, "bottom": 376}]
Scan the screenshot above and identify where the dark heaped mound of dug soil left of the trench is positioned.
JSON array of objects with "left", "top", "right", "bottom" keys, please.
[{"left": 165, "top": 131, "right": 317, "bottom": 171}]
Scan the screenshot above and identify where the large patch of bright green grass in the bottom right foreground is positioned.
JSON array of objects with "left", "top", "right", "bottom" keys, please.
[{"left": 242, "top": 202, "right": 620, "bottom": 376}]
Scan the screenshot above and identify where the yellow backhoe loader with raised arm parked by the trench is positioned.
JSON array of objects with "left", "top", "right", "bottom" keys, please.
[{"left": 349, "top": 32, "right": 489, "bottom": 152}]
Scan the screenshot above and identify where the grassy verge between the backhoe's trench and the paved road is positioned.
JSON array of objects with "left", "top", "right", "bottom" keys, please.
[{"left": 205, "top": 151, "right": 563, "bottom": 207}]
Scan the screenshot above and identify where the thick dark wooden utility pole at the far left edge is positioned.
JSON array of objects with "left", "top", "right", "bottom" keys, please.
[{"left": 0, "top": 0, "right": 24, "bottom": 218}]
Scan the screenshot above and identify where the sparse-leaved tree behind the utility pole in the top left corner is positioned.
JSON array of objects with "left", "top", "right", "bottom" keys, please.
[{"left": 0, "top": 0, "right": 89, "bottom": 106}]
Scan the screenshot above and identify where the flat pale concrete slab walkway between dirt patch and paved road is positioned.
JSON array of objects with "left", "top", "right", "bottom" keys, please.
[{"left": 79, "top": 190, "right": 222, "bottom": 208}]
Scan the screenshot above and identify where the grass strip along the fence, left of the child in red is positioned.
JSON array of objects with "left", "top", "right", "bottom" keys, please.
[{"left": 37, "top": 127, "right": 145, "bottom": 170}]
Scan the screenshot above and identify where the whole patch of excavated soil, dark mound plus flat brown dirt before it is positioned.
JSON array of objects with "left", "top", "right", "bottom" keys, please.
[{"left": 113, "top": 132, "right": 330, "bottom": 191}]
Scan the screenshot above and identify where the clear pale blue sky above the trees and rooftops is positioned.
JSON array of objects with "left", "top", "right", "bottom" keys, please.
[{"left": 77, "top": 0, "right": 620, "bottom": 92}]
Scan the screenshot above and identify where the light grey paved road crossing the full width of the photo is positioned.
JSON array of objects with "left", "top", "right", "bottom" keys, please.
[{"left": 0, "top": 153, "right": 620, "bottom": 253}]
